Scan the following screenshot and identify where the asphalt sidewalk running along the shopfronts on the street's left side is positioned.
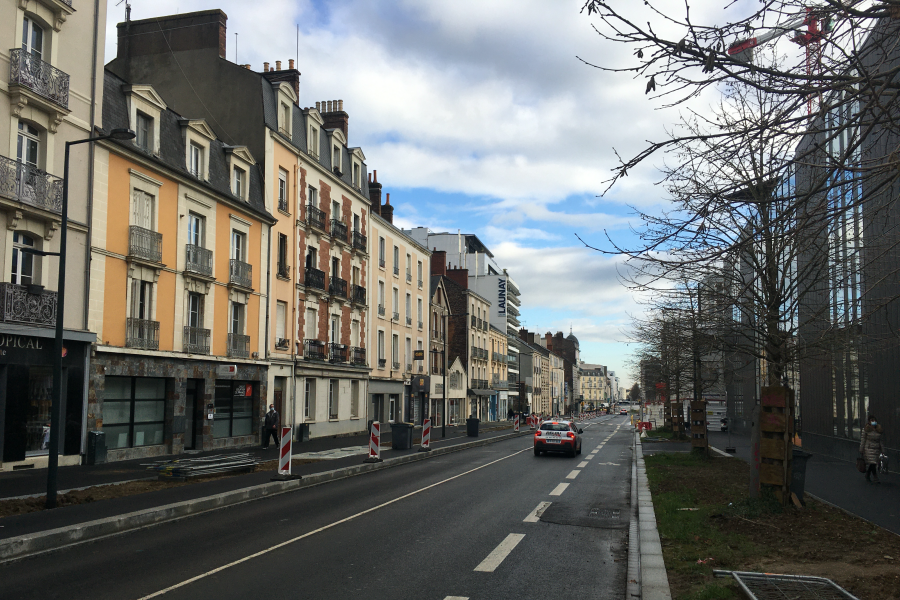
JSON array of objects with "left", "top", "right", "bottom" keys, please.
[{"left": 0, "top": 421, "right": 528, "bottom": 540}]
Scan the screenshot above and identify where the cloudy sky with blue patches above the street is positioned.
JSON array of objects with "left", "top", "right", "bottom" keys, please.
[{"left": 106, "top": 0, "right": 756, "bottom": 386}]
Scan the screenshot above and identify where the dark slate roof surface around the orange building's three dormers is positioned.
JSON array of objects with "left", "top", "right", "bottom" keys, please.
[{"left": 101, "top": 71, "right": 275, "bottom": 221}]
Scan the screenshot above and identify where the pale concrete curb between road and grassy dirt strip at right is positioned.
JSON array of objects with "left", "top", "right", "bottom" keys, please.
[{"left": 634, "top": 437, "right": 672, "bottom": 600}]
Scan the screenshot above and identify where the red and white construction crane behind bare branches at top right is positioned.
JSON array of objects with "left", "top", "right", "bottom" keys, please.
[{"left": 728, "top": 6, "right": 833, "bottom": 114}]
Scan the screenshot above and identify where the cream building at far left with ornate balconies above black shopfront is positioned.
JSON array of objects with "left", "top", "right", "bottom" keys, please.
[{"left": 0, "top": 0, "right": 106, "bottom": 470}]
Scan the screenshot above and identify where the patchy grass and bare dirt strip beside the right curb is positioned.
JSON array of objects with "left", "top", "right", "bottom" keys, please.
[{"left": 645, "top": 454, "right": 900, "bottom": 600}]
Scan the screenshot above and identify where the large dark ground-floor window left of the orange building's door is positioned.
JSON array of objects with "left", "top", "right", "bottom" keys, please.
[{"left": 103, "top": 377, "right": 166, "bottom": 450}]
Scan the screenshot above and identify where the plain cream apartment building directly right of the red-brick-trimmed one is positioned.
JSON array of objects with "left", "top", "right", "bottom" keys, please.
[{"left": 369, "top": 185, "right": 432, "bottom": 423}]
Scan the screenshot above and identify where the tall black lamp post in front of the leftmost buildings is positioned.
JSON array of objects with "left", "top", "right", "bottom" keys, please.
[{"left": 37, "top": 129, "right": 135, "bottom": 508}]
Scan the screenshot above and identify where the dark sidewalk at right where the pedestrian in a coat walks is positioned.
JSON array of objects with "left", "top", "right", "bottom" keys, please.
[{"left": 709, "top": 431, "right": 900, "bottom": 535}]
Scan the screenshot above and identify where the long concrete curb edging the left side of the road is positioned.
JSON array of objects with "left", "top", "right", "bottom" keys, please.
[{"left": 0, "top": 430, "right": 531, "bottom": 564}]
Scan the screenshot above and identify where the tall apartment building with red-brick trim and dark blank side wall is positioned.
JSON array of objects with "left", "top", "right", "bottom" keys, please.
[{"left": 109, "top": 10, "right": 370, "bottom": 437}]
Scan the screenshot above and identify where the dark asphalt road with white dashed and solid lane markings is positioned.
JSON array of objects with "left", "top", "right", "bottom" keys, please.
[{"left": 0, "top": 416, "right": 632, "bottom": 600}]
